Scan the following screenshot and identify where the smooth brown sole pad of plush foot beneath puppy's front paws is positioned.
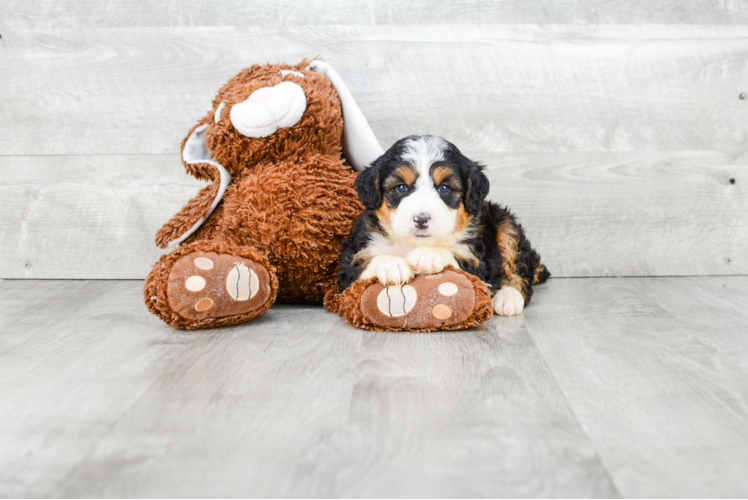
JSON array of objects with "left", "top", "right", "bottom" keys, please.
[{"left": 361, "top": 271, "right": 475, "bottom": 330}]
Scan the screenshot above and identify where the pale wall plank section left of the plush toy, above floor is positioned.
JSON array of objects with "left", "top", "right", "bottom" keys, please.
[{"left": 0, "top": 155, "right": 204, "bottom": 279}]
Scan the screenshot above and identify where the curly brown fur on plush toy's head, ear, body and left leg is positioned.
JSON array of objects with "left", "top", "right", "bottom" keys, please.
[{"left": 144, "top": 60, "right": 363, "bottom": 328}]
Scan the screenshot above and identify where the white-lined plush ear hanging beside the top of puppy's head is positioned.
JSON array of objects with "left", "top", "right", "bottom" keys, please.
[{"left": 308, "top": 61, "right": 384, "bottom": 172}]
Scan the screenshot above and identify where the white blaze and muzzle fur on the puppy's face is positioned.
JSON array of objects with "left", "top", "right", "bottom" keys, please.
[{"left": 391, "top": 136, "right": 457, "bottom": 246}]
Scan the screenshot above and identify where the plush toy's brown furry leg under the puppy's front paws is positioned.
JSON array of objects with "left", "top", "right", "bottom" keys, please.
[{"left": 325, "top": 266, "right": 493, "bottom": 332}]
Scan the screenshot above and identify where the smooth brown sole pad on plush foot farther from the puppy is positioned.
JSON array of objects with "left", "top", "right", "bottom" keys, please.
[{"left": 166, "top": 252, "right": 271, "bottom": 319}]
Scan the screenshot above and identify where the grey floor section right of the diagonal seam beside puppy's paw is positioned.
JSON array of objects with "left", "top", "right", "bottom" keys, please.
[{"left": 525, "top": 277, "right": 748, "bottom": 498}]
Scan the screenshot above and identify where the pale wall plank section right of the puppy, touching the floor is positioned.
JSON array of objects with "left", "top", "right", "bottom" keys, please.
[{"left": 480, "top": 151, "right": 748, "bottom": 276}]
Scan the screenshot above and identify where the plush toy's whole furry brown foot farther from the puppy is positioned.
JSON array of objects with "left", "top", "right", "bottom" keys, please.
[{"left": 143, "top": 241, "right": 278, "bottom": 329}]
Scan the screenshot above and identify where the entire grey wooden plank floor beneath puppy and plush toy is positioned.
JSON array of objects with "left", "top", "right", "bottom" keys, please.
[{"left": 0, "top": 277, "right": 748, "bottom": 498}]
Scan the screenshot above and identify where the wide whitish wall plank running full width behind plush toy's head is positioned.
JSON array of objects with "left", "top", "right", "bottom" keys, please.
[{"left": 0, "top": 24, "right": 748, "bottom": 155}]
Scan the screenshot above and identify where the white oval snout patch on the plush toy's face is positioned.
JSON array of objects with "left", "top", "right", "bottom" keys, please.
[{"left": 230, "top": 82, "right": 306, "bottom": 137}]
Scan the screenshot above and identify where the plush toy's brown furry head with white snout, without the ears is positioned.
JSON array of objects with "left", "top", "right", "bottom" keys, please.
[{"left": 205, "top": 61, "right": 343, "bottom": 175}]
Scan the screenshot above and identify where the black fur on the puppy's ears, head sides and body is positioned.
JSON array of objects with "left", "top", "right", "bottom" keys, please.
[{"left": 338, "top": 136, "right": 550, "bottom": 304}]
